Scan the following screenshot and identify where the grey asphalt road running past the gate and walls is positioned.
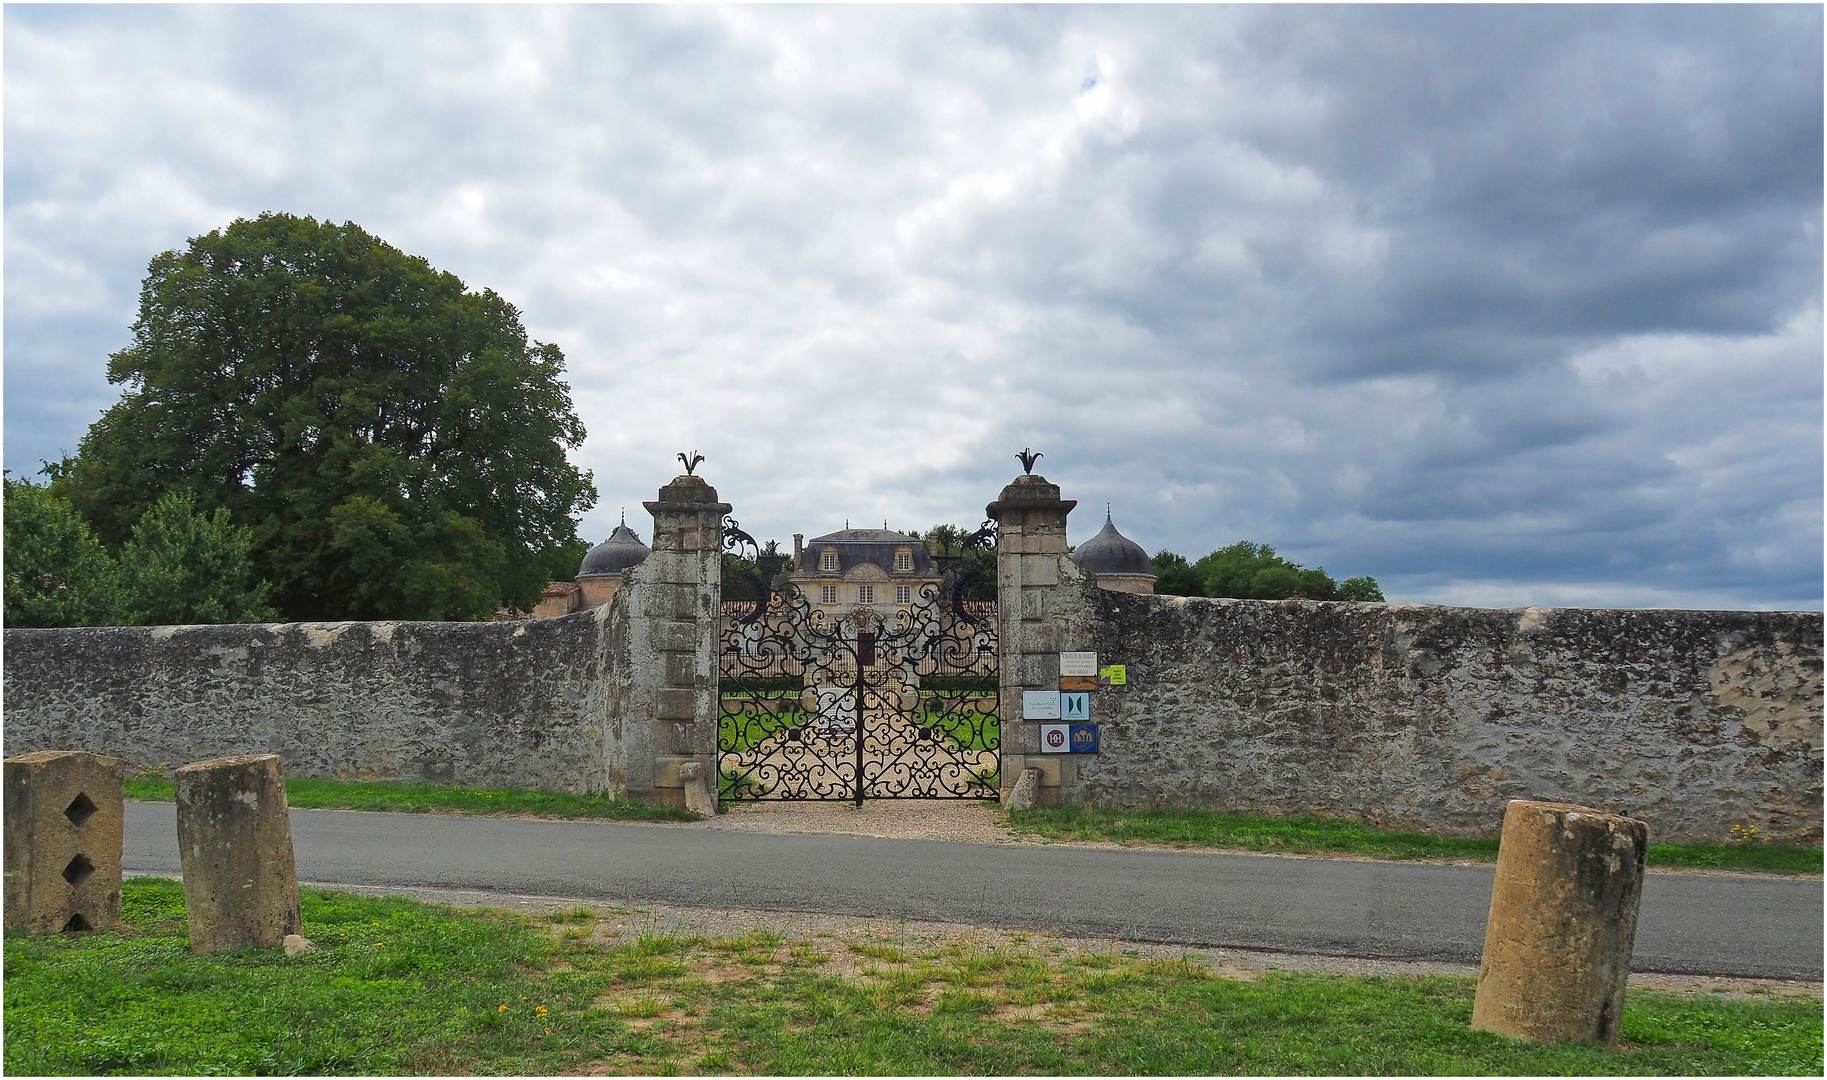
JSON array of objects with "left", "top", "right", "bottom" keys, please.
[{"left": 124, "top": 802, "right": 1822, "bottom": 981}]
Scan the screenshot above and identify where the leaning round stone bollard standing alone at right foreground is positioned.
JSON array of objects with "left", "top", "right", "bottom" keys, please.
[{"left": 1473, "top": 799, "right": 1650, "bottom": 1045}]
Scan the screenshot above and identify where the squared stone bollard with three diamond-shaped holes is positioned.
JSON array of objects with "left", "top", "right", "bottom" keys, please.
[{"left": 5, "top": 749, "right": 124, "bottom": 934}]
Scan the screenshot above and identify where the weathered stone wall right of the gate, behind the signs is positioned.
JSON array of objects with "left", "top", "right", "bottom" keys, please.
[{"left": 1074, "top": 583, "right": 1822, "bottom": 844}]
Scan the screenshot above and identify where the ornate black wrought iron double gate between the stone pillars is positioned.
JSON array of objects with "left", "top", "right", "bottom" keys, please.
[{"left": 718, "top": 519, "right": 1001, "bottom": 806}]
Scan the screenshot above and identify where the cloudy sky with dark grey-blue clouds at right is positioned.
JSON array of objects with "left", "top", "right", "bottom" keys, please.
[{"left": 4, "top": 5, "right": 1823, "bottom": 609}]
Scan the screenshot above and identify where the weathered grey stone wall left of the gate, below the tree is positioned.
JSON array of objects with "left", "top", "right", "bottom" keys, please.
[{"left": 4, "top": 609, "right": 618, "bottom": 791}]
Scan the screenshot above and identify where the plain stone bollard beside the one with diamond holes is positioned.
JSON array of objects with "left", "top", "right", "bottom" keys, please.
[{"left": 174, "top": 753, "right": 303, "bottom": 954}]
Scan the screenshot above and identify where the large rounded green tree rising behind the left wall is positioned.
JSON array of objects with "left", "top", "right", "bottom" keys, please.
[{"left": 53, "top": 214, "right": 596, "bottom": 619}]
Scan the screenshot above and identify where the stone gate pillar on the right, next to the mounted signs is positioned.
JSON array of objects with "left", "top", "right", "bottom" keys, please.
[{"left": 985, "top": 475, "right": 1093, "bottom": 806}]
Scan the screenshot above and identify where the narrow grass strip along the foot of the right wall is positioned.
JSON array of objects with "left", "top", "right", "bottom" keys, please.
[{"left": 1009, "top": 804, "right": 1822, "bottom": 874}]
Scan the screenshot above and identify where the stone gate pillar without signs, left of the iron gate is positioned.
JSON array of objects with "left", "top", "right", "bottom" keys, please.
[{"left": 616, "top": 475, "right": 729, "bottom": 813}]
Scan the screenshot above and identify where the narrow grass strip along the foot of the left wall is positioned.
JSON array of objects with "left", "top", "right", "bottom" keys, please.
[{"left": 126, "top": 777, "right": 698, "bottom": 821}]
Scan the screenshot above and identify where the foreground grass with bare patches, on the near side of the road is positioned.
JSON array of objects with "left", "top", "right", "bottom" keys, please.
[{"left": 4, "top": 879, "right": 1822, "bottom": 1076}]
